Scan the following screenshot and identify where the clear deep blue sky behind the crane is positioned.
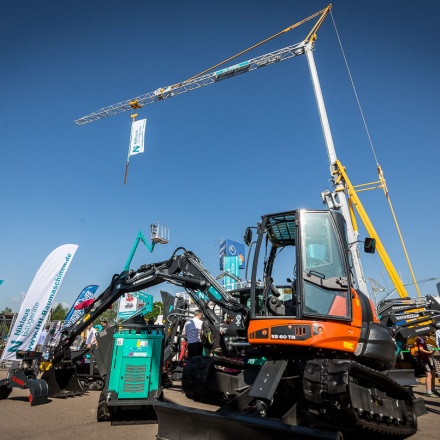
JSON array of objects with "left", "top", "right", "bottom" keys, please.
[{"left": 0, "top": 0, "right": 440, "bottom": 311}]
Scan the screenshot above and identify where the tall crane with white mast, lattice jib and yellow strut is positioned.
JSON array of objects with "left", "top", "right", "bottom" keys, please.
[{"left": 74, "top": 4, "right": 422, "bottom": 297}]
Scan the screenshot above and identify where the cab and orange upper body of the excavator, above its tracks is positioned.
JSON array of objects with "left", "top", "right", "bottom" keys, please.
[{"left": 247, "top": 209, "right": 395, "bottom": 370}]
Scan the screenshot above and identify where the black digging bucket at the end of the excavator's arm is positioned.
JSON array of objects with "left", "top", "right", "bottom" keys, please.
[{"left": 41, "top": 365, "right": 84, "bottom": 397}]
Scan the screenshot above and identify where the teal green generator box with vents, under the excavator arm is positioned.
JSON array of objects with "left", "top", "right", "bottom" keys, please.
[{"left": 97, "top": 323, "right": 164, "bottom": 422}]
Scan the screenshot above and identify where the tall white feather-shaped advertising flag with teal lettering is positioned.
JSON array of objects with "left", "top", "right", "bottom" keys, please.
[{"left": 2, "top": 244, "right": 78, "bottom": 360}]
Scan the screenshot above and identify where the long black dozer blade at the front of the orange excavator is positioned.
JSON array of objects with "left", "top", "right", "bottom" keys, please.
[{"left": 154, "top": 400, "right": 343, "bottom": 440}]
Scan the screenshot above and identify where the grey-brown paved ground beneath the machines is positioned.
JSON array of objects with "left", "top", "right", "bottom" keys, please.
[{"left": 0, "top": 370, "right": 440, "bottom": 440}]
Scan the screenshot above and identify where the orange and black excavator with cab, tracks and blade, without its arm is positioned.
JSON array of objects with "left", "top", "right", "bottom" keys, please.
[{"left": 155, "top": 209, "right": 426, "bottom": 440}]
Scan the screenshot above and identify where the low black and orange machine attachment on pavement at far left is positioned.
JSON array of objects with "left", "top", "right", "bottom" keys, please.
[{"left": 0, "top": 350, "right": 48, "bottom": 406}]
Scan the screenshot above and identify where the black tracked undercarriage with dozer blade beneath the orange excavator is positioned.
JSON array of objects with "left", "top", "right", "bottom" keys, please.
[{"left": 162, "top": 358, "right": 423, "bottom": 440}]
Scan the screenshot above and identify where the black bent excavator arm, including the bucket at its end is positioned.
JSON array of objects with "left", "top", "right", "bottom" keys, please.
[{"left": 43, "top": 248, "right": 248, "bottom": 397}]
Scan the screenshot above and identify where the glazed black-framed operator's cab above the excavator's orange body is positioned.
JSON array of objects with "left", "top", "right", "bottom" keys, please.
[{"left": 252, "top": 210, "right": 351, "bottom": 320}]
